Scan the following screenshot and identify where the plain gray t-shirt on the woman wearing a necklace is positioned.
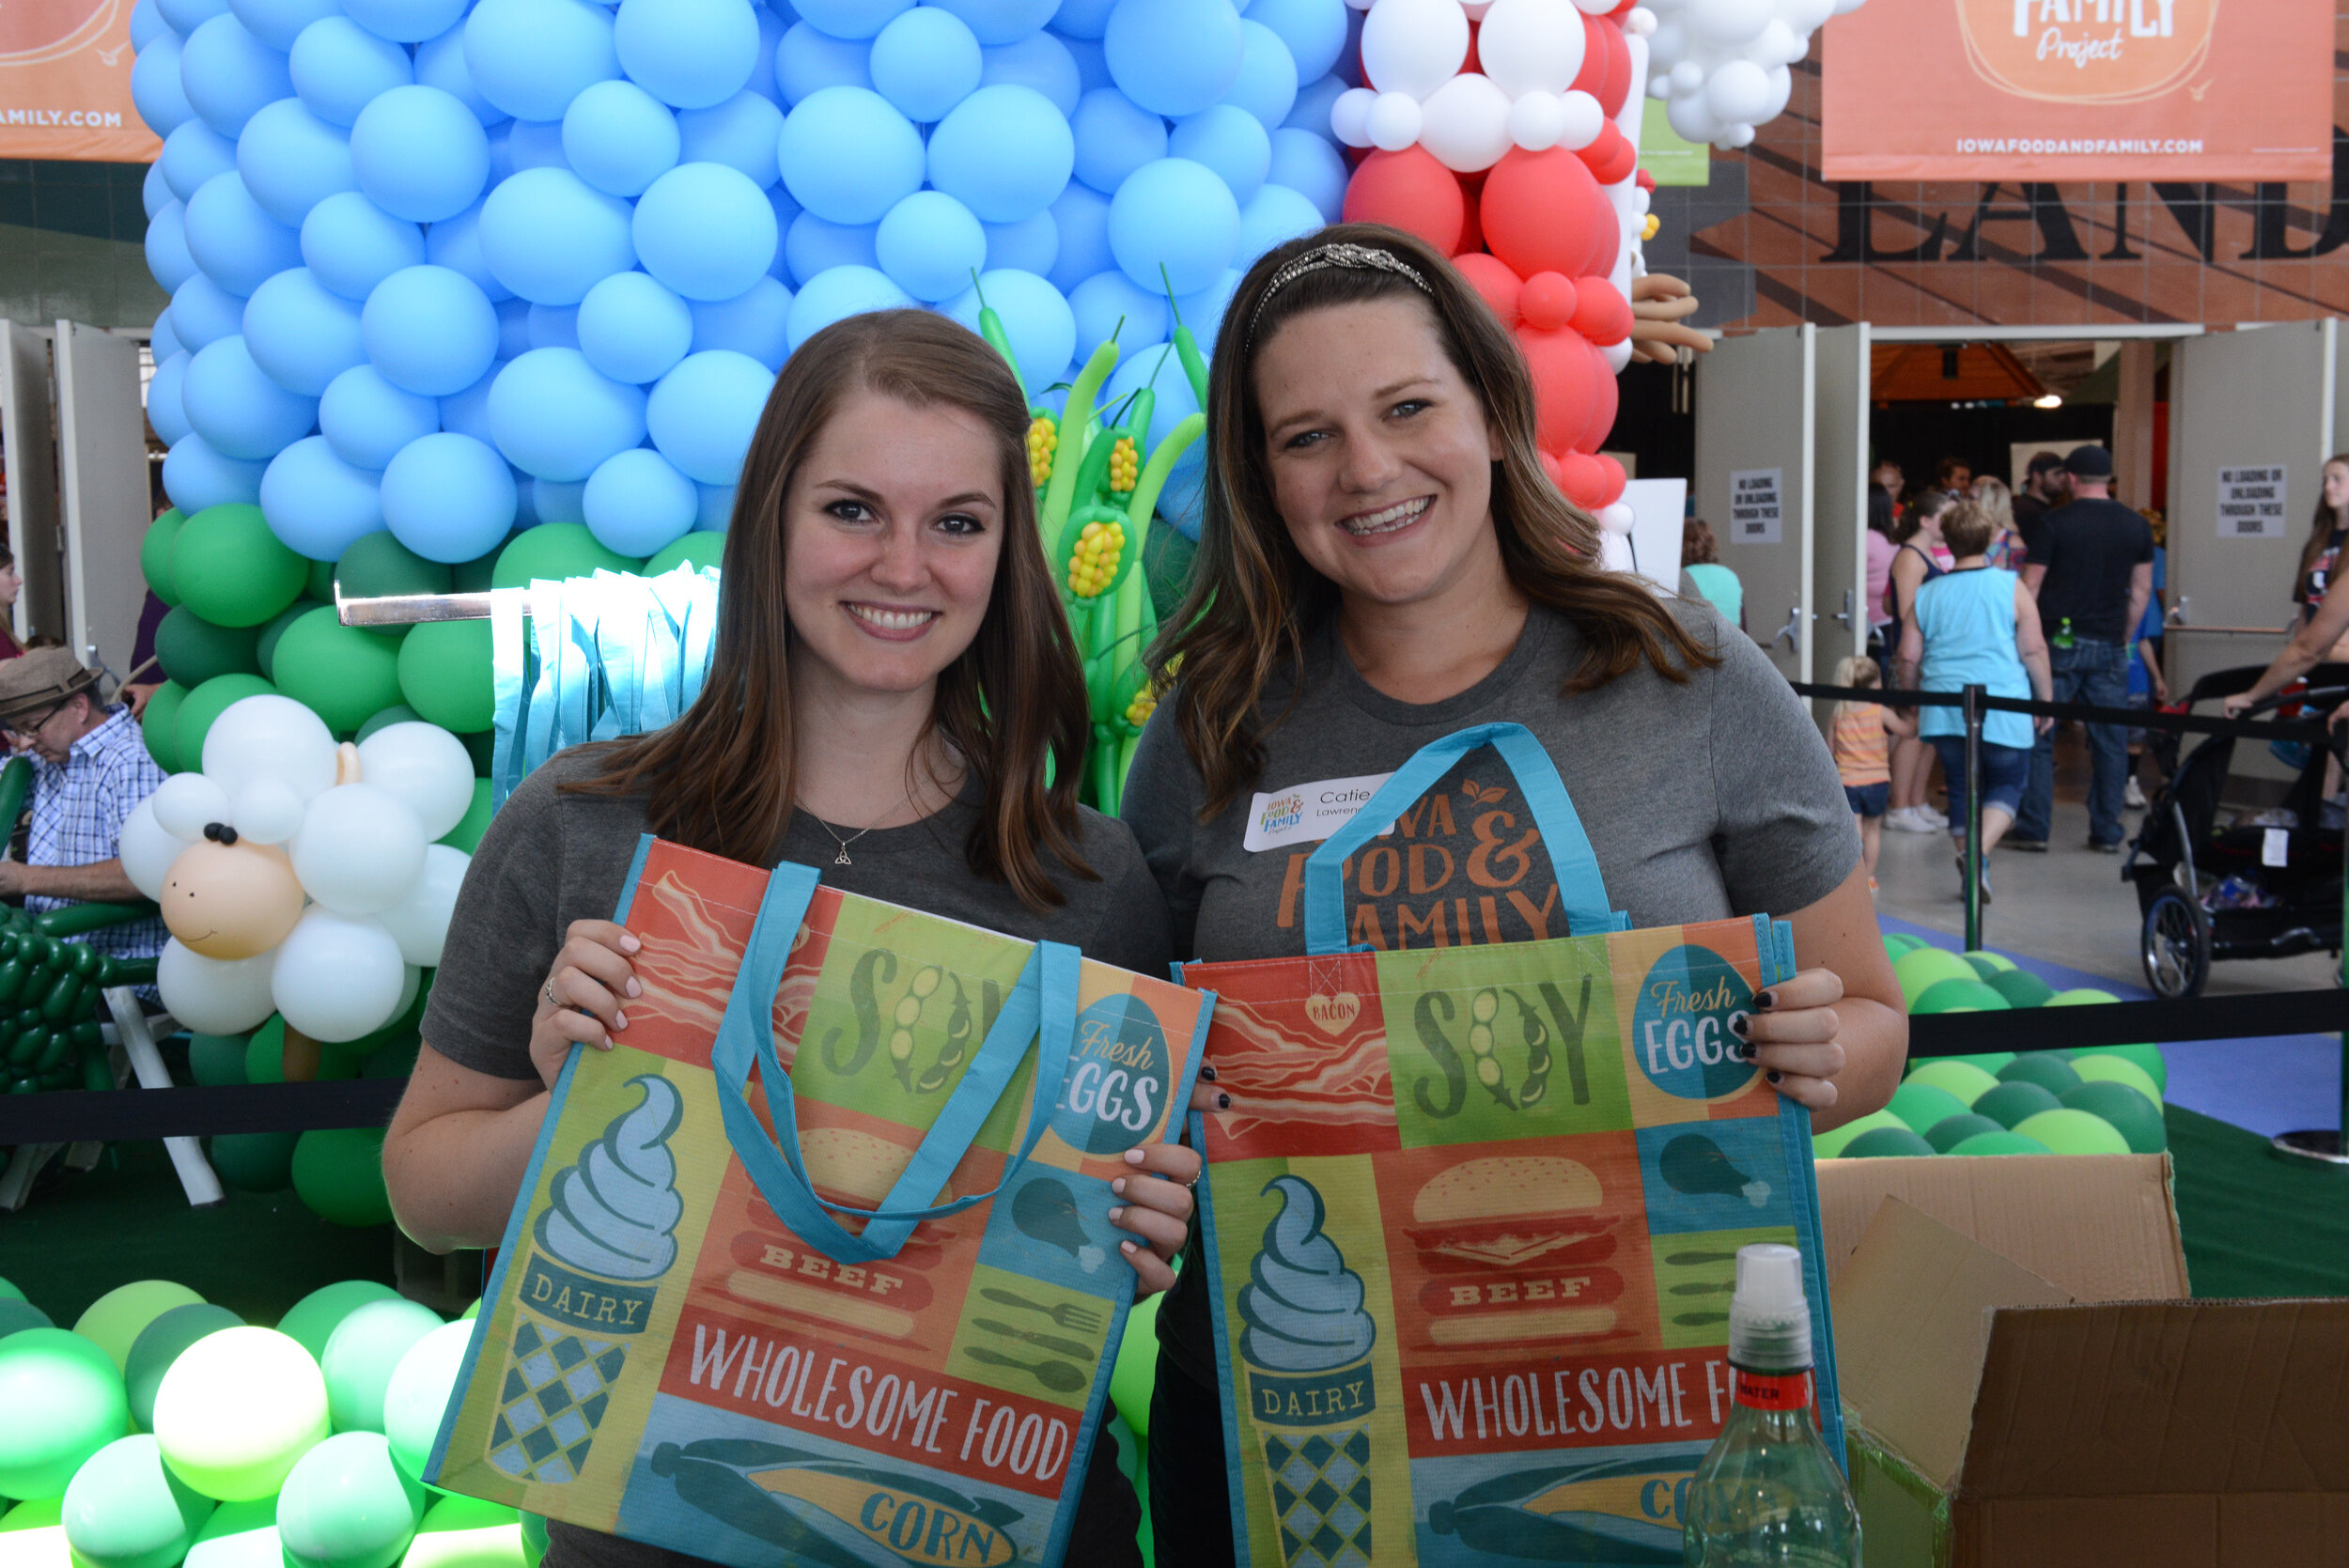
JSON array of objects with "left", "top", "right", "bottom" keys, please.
[{"left": 423, "top": 752, "right": 1174, "bottom": 1568}]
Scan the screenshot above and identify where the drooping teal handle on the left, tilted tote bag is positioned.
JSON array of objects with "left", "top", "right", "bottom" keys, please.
[{"left": 709, "top": 862, "right": 1079, "bottom": 1263}]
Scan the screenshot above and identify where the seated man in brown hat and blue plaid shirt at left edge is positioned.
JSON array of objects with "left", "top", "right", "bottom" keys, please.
[{"left": 0, "top": 648, "right": 164, "bottom": 957}]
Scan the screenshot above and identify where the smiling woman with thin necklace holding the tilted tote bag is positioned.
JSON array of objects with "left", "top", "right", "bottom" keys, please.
[{"left": 383, "top": 310, "right": 1198, "bottom": 1568}]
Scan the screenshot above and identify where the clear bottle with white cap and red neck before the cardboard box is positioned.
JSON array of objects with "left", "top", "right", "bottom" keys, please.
[{"left": 1682, "top": 1242, "right": 1860, "bottom": 1568}]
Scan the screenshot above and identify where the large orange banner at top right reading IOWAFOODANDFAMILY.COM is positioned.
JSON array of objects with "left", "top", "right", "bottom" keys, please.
[{"left": 1821, "top": 0, "right": 2333, "bottom": 180}]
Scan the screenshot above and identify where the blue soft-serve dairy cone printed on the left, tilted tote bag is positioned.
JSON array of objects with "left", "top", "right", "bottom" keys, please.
[{"left": 489, "top": 1075, "right": 684, "bottom": 1486}]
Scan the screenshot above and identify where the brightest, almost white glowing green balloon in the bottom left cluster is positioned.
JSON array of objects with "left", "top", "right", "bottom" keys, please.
[{"left": 155, "top": 1328, "right": 327, "bottom": 1502}]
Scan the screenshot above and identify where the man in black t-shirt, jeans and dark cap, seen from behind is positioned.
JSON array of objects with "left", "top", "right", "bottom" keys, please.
[{"left": 2006, "top": 446, "right": 2155, "bottom": 854}]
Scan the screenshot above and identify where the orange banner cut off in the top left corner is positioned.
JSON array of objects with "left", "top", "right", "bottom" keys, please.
[{"left": 0, "top": 0, "right": 163, "bottom": 164}]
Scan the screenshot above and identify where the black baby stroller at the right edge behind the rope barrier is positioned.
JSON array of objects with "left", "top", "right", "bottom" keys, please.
[{"left": 2122, "top": 664, "right": 2349, "bottom": 998}]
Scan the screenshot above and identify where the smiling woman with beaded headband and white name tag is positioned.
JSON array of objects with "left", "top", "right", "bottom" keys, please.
[{"left": 1126, "top": 223, "right": 1907, "bottom": 1563}]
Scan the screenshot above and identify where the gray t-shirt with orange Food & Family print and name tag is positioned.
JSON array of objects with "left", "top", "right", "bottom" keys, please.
[{"left": 1123, "top": 598, "right": 1860, "bottom": 1385}]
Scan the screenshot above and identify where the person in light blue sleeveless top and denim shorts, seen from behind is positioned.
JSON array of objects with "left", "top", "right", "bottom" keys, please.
[{"left": 1901, "top": 500, "right": 2053, "bottom": 904}]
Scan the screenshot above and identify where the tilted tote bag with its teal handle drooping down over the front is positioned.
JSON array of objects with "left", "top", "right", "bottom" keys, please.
[{"left": 428, "top": 838, "right": 1212, "bottom": 1568}]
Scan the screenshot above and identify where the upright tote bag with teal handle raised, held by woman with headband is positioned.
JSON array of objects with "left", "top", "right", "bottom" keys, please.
[{"left": 1182, "top": 723, "right": 1842, "bottom": 1568}]
